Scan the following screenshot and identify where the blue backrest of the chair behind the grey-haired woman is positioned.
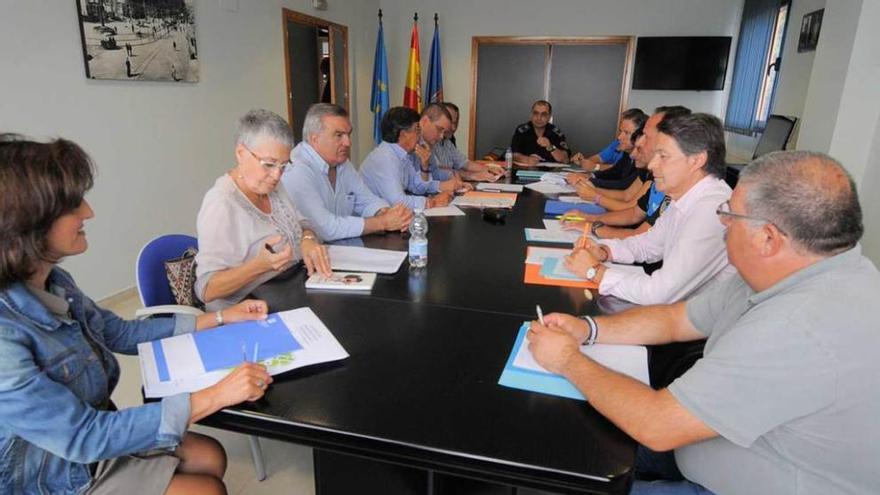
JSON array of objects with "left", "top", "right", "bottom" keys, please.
[{"left": 135, "top": 234, "right": 199, "bottom": 307}]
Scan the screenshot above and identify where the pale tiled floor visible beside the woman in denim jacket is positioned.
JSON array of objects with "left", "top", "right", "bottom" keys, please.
[{"left": 102, "top": 290, "right": 315, "bottom": 495}]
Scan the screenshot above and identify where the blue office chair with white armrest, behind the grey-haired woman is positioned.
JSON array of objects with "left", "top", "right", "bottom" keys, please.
[{"left": 135, "top": 234, "right": 266, "bottom": 481}]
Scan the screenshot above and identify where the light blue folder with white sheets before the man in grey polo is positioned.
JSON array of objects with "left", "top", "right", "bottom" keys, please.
[{"left": 498, "top": 322, "right": 650, "bottom": 400}]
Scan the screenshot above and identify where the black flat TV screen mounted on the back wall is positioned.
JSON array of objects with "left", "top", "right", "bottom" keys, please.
[{"left": 633, "top": 36, "right": 731, "bottom": 91}]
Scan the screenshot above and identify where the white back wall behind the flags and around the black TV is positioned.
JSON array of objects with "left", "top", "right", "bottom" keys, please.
[{"left": 373, "top": 0, "right": 743, "bottom": 157}]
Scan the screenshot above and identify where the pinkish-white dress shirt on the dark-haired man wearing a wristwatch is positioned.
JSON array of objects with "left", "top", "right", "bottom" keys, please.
[{"left": 599, "top": 175, "right": 736, "bottom": 305}]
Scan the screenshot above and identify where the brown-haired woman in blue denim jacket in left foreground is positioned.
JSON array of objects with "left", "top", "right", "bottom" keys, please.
[{"left": 0, "top": 134, "right": 272, "bottom": 494}]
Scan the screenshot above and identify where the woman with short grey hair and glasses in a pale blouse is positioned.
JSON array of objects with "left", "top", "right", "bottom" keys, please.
[{"left": 196, "top": 110, "right": 330, "bottom": 312}]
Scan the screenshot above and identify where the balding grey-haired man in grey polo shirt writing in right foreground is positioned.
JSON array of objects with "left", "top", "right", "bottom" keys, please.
[{"left": 529, "top": 152, "right": 880, "bottom": 495}]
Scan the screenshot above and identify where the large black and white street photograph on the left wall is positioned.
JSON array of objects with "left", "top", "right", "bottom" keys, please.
[{"left": 74, "top": 0, "right": 199, "bottom": 82}]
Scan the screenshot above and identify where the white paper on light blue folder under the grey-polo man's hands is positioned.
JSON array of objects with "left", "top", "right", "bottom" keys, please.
[{"left": 513, "top": 326, "right": 650, "bottom": 384}]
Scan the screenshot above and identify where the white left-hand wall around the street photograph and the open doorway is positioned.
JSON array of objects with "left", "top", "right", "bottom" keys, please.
[{"left": 0, "top": 0, "right": 378, "bottom": 297}]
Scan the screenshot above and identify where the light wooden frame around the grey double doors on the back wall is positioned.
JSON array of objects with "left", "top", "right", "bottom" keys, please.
[{"left": 468, "top": 36, "right": 636, "bottom": 160}]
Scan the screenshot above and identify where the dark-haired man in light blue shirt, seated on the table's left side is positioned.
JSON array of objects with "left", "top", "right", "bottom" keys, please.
[{"left": 360, "top": 107, "right": 454, "bottom": 209}]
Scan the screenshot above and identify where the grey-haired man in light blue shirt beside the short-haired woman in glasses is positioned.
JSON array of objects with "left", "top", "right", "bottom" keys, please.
[{"left": 281, "top": 103, "right": 412, "bottom": 241}]
